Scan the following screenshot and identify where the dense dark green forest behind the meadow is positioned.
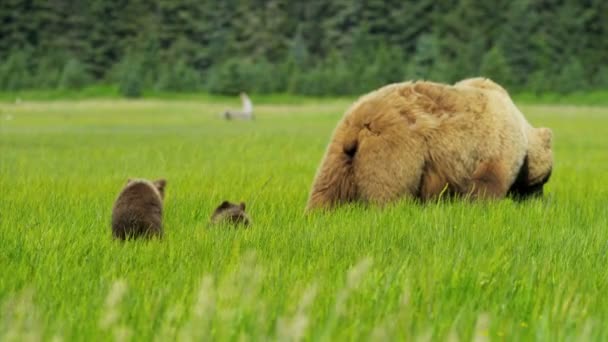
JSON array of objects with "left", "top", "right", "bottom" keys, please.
[{"left": 0, "top": 0, "right": 608, "bottom": 96}]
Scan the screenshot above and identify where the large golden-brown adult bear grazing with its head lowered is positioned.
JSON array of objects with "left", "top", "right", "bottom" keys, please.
[{"left": 308, "top": 78, "right": 552, "bottom": 209}]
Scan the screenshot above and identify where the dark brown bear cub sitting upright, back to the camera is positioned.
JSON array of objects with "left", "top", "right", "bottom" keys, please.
[{"left": 112, "top": 179, "right": 167, "bottom": 240}]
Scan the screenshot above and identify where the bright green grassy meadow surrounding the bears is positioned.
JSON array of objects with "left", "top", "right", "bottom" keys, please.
[{"left": 0, "top": 99, "right": 608, "bottom": 341}]
